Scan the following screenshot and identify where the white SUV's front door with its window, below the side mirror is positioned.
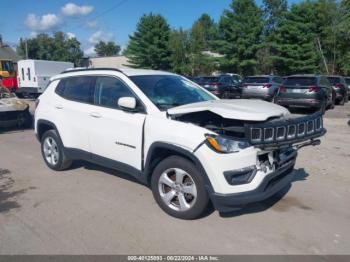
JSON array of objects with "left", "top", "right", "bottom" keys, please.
[{"left": 89, "top": 76, "right": 146, "bottom": 170}]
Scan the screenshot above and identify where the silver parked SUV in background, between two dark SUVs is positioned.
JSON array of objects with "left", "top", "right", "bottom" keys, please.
[{"left": 242, "top": 75, "right": 283, "bottom": 101}]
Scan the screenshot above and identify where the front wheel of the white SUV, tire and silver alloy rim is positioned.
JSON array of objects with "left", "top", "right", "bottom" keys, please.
[{"left": 151, "top": 156, "right": 209, "bottom": 219}]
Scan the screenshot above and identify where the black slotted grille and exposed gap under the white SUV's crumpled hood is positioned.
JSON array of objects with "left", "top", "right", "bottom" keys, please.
[{"left": 171, "top": 111, "right": 326, "bottom": 151}]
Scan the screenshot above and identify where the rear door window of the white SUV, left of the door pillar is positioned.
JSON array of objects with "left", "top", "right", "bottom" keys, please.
[{"left": 56, "top": 76, "right": 95, "bottom": 104}]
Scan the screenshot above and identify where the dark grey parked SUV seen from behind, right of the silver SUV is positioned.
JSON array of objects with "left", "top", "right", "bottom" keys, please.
[{"left": 276, "top": 75, "right": 336, "bottom": 113}]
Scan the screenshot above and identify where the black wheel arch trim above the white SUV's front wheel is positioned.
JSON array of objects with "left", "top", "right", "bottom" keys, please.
[{"left": 145, "top": 147, "right": 197, "bottom": 185}]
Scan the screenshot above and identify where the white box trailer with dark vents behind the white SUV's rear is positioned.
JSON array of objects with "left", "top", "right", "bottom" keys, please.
[{"left": 17, "top": 59, "right": 74, "bottom": 95}]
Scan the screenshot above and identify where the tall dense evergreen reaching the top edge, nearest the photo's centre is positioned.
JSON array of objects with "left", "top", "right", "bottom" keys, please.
[{"left": 218, "top": 0, "right": 263, "bottom": 75}]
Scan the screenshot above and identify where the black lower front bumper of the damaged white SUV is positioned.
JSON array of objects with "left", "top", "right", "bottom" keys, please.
[{"left": 209, "top": 159, "right": 295, "bottom": 212}]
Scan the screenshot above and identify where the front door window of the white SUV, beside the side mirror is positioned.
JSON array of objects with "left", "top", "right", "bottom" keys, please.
[{"left": 94, "top": 76, "right": 136, "bottom": 108}]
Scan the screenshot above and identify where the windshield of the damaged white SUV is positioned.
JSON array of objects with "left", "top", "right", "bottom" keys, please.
[{"left": 130, "top": 75, "right": 215, "bottom": 110}]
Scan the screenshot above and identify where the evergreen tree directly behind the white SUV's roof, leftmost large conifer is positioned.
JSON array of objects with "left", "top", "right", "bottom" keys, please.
[{"left": 125, "top": 13, "right": 171, "bottom": 70}]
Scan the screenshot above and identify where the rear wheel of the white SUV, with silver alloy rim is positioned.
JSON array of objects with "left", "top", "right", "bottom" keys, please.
[{"left": 41, "top": 129, "right": 72, "bottom": 171}]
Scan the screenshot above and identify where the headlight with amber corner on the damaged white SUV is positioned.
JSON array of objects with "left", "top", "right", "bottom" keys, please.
[{"left": 205, "top": 135, "right": 250, "bottom": 153}]
